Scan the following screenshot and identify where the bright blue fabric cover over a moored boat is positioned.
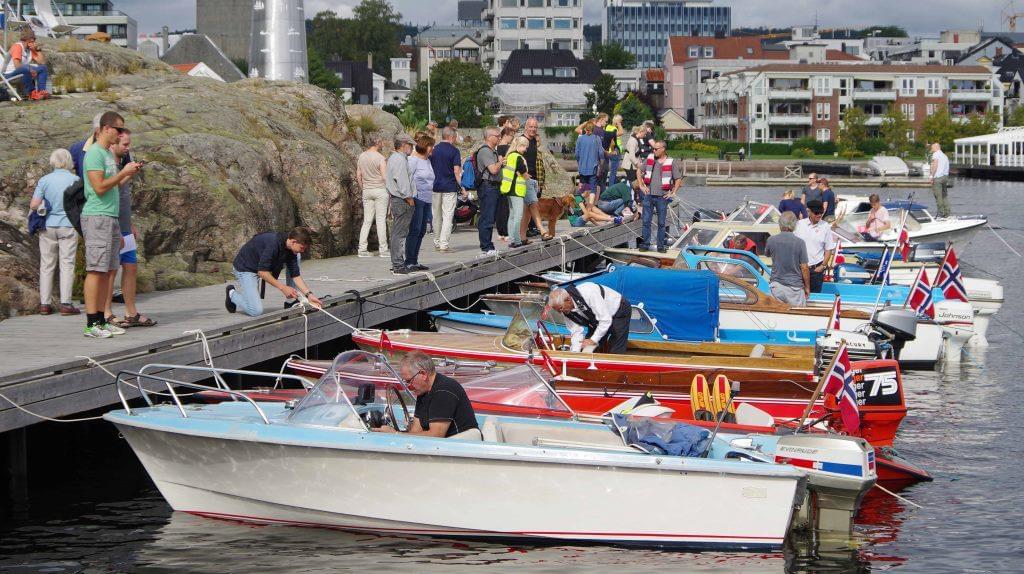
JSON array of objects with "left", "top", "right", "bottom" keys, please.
[{"left": 574, "top": 265, "right": 719, "bottom": 342}]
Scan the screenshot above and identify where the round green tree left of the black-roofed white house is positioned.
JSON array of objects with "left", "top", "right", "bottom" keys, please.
[{"left": 403, "top": 60, "right": 492, "bottom": 128}]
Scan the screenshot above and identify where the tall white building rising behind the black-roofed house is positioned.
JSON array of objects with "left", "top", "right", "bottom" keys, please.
[{"left": 480, "top": 0, "right": 593, "bottom": 78}]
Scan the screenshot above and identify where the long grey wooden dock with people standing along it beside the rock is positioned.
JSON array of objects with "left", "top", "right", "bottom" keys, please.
[{"left": 0, "top": 221, "right": 639, "bottom": 433}]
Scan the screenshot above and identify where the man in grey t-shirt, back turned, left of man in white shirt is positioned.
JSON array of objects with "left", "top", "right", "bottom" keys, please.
[{"left": 765, "top": 211, "right": 811, "bottom": 307}]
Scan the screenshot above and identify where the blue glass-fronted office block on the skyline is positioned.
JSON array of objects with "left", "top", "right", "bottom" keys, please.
[{"left": 601, "top": 0, "right": 732, "bottom": 70}]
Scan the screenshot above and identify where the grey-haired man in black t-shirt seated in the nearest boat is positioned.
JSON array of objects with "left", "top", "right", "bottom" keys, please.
[{"left": 378, "top": 351, "right": 478, "bottom": 438}]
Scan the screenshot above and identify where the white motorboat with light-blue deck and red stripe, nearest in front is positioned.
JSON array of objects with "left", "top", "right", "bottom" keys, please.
[{"left": 104, "top": 351, "right": 806, "bottom": 549}]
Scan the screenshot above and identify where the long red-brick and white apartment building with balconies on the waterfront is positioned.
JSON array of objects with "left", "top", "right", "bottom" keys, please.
[{"left": 703, "top": 63, "right": 1002, "bottom": 142}]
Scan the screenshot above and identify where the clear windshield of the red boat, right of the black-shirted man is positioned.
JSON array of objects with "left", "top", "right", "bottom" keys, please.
[{"left": 460, "top": 364, "right": 574, "bottom": 418}]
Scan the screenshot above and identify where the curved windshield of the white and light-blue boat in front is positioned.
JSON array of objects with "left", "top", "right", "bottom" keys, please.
[{"left": 288, "top": 351, "right": 416, "bottom": 431}]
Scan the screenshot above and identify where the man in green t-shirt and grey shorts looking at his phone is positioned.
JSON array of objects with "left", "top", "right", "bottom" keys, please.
[{"left": 82, "top": 112, "right": 142, "bottom": 339}]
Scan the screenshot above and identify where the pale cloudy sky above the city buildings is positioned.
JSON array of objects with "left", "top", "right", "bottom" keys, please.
[{"left": 121, "top": 0, "right": 1007, "bottom": 36}]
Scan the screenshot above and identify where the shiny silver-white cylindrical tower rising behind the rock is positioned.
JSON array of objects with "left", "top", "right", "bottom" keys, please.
[{"left": 249, "top": 0, "right": 309, "bottom": 82}]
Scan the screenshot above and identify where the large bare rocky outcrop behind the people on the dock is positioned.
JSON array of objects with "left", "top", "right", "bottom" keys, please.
[{"left": 0, "top": 40, "right": 401, "bottom": 312}]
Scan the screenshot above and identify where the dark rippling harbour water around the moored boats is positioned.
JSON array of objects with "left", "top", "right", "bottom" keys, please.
[{"left": 0, "top": 181, "right": 1024, "bottom": 573}]
